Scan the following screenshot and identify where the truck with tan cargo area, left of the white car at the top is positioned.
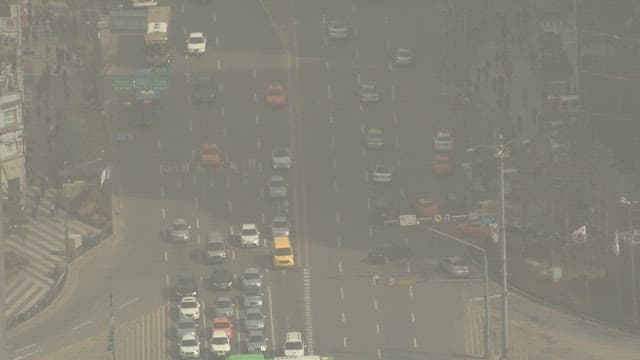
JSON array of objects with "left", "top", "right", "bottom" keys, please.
[{"left": 144, "top": 6, "right": 171, "bottom": 66}]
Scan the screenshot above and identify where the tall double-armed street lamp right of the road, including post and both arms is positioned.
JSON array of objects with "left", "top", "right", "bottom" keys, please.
[{"left": 467, "top": 134, "right": 530, "bottom": 359}]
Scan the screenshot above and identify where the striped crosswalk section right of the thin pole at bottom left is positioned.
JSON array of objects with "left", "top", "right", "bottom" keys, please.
[{"left": 115, "top": 304, "right": 171, "bottom": 360}]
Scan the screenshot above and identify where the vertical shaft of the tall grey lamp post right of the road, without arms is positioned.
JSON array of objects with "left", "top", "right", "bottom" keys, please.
[{"left": 497, "top": 134, "right": 509, "bottom": 360}]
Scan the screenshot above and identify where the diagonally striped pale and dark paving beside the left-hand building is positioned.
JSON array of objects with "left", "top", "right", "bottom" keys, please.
[{"left": 5, "top": 187, "right": 100, "bottom": 316}]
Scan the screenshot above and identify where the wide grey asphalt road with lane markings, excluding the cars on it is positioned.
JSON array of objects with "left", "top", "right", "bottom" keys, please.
[{"left": 7, "top": 0, "right": 488, "bottom": 359}]
